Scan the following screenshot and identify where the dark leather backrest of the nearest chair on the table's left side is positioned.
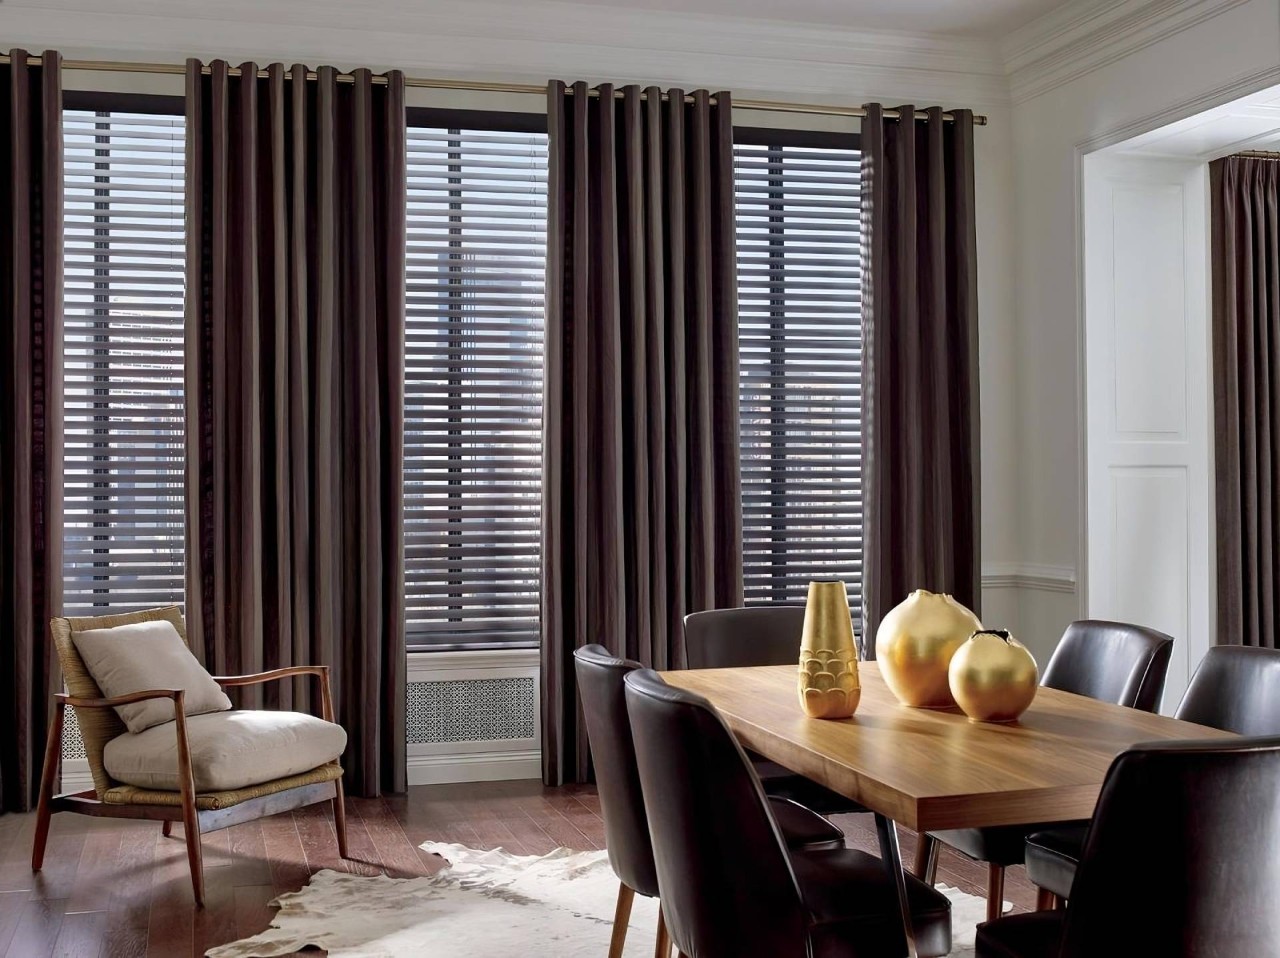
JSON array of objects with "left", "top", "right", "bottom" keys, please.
[{"left": 626, "top": 669, "right": 809, "bottom": 958}]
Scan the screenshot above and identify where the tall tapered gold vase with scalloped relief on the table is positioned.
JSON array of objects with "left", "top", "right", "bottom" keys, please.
[{"left": 799, "top": 579, "right": 863, "bottom": 719}]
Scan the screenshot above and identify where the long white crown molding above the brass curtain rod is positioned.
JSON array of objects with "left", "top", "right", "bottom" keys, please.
[{"left": 0, "top": 0, "right": 1009, "bottom": 108}]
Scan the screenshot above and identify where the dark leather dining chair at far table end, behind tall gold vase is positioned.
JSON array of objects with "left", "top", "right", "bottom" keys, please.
[{"left": 685, "top": 606, "right": 867, "bottom": 815}]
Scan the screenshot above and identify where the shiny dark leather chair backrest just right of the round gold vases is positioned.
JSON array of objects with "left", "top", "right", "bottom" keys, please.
[{"left": 1041, "top": 619, "right": 1174, "bottom": 712}]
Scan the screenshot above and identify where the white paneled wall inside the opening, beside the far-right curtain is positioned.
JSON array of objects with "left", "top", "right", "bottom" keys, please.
[{"left": 1084, "top": 154, "right": 1213, "bottom": 708}]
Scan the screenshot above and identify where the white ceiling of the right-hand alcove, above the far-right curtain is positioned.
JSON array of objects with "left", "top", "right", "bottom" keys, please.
[{"left": 1116, "top": 87, "right": 1280, "bottom": 160}]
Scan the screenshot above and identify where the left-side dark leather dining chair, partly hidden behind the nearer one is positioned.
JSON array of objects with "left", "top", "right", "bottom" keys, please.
[{"left": 573, "top": 645, "right": 845, "bottom": 958}]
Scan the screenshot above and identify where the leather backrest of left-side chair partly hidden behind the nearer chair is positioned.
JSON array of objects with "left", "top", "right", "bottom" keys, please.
[{"left": 573, "top": 645, "right": 658, "bottom": 898}]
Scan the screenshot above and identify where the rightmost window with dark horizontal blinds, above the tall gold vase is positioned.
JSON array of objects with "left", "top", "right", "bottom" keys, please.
[{"left": 733, "top": 129, "right": 863, "bottom": 617}]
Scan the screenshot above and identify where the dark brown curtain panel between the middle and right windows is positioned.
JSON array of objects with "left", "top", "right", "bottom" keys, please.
[{"left": 541, "top": 82, "right": 742, "bottom": 784}]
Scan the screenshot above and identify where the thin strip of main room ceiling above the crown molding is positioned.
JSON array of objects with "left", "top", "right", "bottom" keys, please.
[{"left": 565, "top": 0, "right": 1064, "bottom": 37}]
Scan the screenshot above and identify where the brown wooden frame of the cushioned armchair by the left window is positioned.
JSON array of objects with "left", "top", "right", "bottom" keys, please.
[{"left": 31, "top": 610, "right": 348, "bottom": 907}]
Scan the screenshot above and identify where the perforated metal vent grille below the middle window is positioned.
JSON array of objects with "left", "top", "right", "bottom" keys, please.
[{"left": 406, "top": 678, "right": 538, "bottom": 745}]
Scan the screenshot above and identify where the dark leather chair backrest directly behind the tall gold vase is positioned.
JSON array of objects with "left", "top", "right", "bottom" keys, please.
[{"left": 685, "top": 606, "right": 804, "bottom": 669}]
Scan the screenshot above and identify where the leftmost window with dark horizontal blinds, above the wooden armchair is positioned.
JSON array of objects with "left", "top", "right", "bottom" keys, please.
[{"left": 63, "top": 93, "right": 184, "bottom": 615}]
